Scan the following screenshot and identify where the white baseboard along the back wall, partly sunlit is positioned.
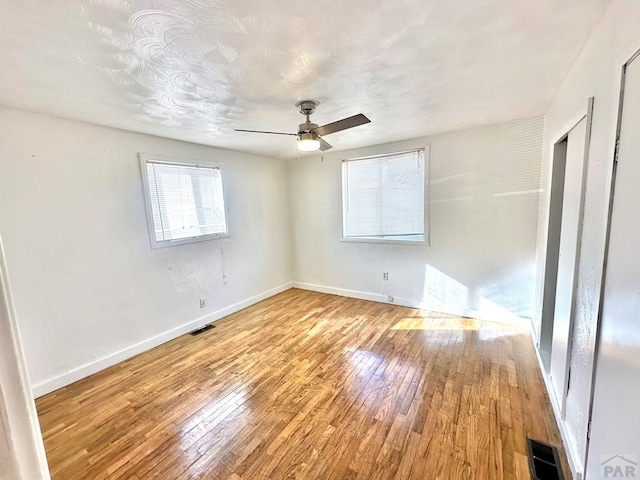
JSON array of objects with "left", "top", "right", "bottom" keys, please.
[{"left": 293, "top": 281, "right": 531, "bottom": 326}]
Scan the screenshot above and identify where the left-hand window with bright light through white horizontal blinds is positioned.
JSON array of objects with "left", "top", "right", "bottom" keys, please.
[{"left": 140, "top": 154, "right": 227, "bottom": 248}]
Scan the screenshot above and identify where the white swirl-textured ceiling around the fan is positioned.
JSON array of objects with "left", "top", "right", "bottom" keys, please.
[{"left": 0, "top": 0, "right": 610, "bottom": 157}]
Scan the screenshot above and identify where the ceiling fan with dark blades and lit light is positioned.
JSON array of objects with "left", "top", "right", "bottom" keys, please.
[{"left": 235, "top": 100, "right": 371, "bottom": 152}]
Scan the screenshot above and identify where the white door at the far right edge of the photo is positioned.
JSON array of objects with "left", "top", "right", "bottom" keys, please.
[{"left": 587, "top": 51, "right": 640, "bottom": 479}]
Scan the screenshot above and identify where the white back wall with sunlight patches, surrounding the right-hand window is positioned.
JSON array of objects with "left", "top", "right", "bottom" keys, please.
[{"left": 287, "top": 118, "right": 543, "bottom": 320}]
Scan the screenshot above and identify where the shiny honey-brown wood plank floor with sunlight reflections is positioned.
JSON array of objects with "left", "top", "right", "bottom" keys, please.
[{"left": 37, "top": 289, "right": 570, "bottom": 480}]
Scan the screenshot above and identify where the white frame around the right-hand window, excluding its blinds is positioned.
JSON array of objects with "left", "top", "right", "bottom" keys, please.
[{"left": 340, "top": 144, "right": 431, "bottom": 247}]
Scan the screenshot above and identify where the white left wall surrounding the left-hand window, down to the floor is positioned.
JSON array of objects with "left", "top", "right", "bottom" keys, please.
[{"left": 0, "top": 108, "right": 291, "bottom": 394}]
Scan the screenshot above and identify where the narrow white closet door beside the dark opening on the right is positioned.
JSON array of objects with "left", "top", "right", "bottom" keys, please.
[{"left": 550, "top": 116, "right": 591, "bottom": 415}]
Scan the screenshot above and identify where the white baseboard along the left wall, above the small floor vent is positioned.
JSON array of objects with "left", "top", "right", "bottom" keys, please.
[{"left": 31, "top": 282, "right": 293, "bottom": 398}]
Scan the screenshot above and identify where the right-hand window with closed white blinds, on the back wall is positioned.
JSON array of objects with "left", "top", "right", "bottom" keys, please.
[{"left": 342, "top": 149, "right": 427, "bottom": 244}]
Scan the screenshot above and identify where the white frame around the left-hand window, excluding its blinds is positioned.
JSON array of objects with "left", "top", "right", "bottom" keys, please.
[{"left": 139, "top": 153, "right": 231, "bottom": 250}]
